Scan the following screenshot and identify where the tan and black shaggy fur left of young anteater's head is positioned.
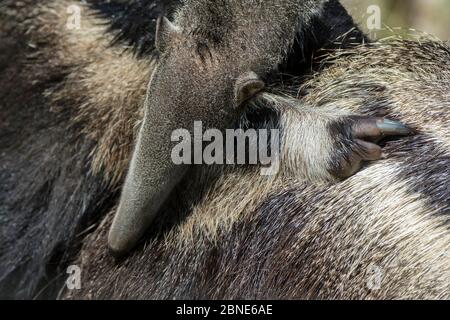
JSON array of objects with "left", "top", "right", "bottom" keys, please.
[{"left": 0, "top": 0, "right": 365, "bottom": 298}]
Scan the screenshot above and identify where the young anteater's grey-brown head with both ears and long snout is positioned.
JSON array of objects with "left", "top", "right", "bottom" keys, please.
[{"left": 108, "top": 18, "right": 264, "bottom": 255}]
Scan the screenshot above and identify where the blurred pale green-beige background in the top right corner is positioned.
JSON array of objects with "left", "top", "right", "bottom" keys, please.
[{"left": 341, "top": 0, "right": 450, "bottom": 40}]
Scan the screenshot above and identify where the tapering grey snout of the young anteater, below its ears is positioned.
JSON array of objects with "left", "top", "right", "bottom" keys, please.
[{"left": 108, "top": 114, "right": 187, "bottom": 256}]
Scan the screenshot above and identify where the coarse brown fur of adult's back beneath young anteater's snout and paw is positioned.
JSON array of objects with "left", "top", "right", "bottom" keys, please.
[{"left": 64, "top": 41, "right": 450, "bottom": 299}]
